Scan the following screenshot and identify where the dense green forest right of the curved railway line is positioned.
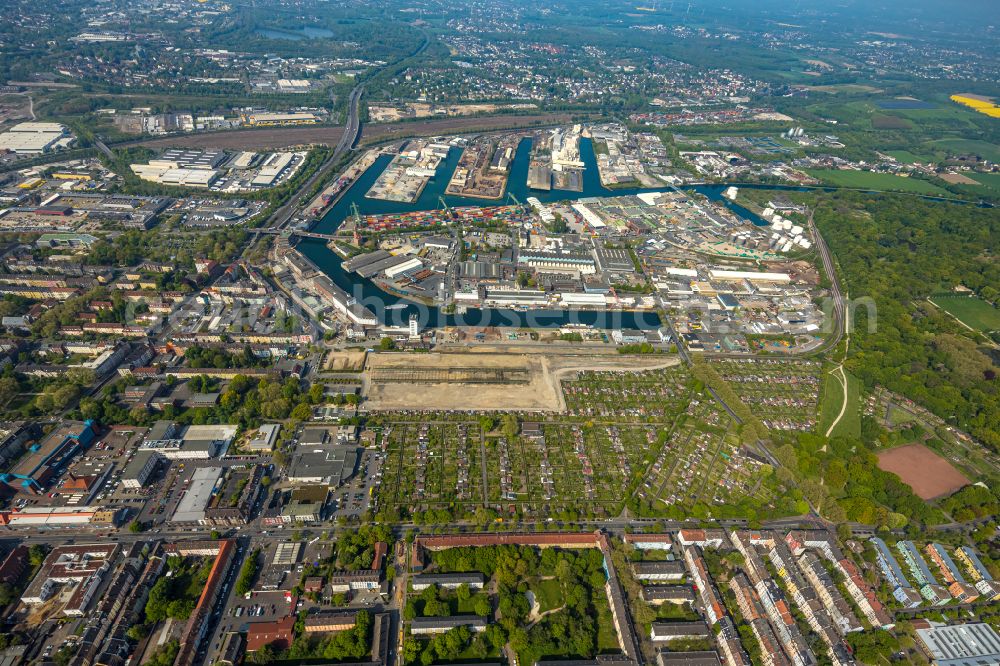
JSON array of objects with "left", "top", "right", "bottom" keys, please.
[{"left": 808, "top": 192, "right": 1000, "bottom": 451}]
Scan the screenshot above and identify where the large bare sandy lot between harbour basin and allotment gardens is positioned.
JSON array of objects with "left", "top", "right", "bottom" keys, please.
[{"left": 365, "top": 351, "right": 679, "bottom": 412}]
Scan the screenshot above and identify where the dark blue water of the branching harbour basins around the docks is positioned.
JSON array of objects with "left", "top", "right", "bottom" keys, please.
[{"left": 298, "top": 139, "right": 766, "bottom": 330}]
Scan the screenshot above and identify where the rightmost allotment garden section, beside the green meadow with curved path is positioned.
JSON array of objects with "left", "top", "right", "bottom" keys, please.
[{"left": 712, "top": 359, "right": 822, "bottom": 430}]
